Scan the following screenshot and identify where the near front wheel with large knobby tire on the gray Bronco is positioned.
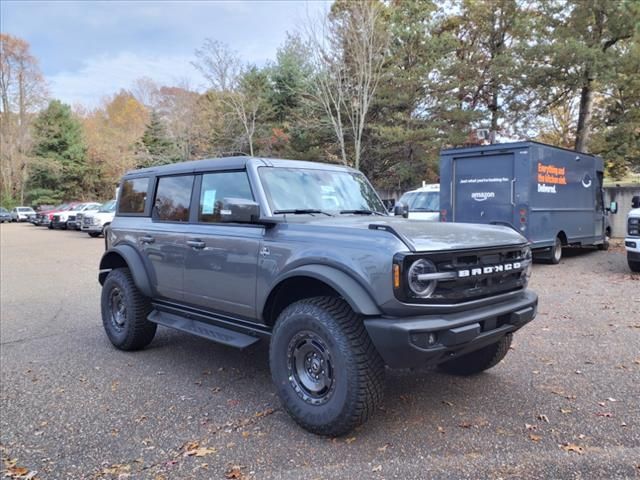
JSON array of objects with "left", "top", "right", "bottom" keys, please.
[{"left": 269, "top": 297, "right": 384, "bottom": 436}]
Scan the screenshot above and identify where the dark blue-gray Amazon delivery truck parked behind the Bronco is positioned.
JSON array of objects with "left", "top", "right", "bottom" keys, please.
[{"left": 440, "top": 141, "right": 617, "bottom": 263}]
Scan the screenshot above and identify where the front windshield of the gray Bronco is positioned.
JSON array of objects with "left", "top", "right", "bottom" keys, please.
[{"left": 258, "top": 167, "right": 386, "bottom": 213}]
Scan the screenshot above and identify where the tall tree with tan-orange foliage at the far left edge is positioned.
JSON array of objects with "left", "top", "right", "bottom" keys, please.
[{"left": 0, "top": 34, "right": 47, "bottom": 203}]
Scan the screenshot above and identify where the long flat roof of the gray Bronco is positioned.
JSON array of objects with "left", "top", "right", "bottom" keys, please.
[{"left": 124, "top": 156, "right": 357, "bottom": 178}]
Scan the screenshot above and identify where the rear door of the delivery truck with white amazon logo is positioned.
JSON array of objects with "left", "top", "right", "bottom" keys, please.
[{"left": 452, "top": 153, "right": 515, "bottom": 225}]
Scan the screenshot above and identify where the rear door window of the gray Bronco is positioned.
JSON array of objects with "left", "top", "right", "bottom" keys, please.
[{"left": 153, "top": 175, "right": 193, "bottom": 222}]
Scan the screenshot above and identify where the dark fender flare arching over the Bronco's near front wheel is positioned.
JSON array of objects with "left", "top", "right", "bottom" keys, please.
[{"left": 260, "top": 264, "right": 382, "bottom": 315}]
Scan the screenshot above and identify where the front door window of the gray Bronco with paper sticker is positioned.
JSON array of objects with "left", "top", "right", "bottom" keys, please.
[{"left": 198, "top": 172, "right": 253, "bottom": 222}]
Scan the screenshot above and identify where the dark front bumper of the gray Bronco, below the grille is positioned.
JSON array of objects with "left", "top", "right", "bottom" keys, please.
[{"left": 364, "top": 290, "right": 538, "bottom": 368}]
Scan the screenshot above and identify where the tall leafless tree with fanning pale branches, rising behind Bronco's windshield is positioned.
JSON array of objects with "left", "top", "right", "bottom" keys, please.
[{"left": 306, "top": 0, "right": 389, "bottom": 168}]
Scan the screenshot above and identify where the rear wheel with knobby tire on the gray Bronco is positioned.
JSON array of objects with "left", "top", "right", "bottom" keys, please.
[{"left": 101, "top": 268, "right": 157, "bottom": 350}]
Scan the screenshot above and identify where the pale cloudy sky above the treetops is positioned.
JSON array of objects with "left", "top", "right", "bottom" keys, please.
[{"left": 0, "top": 0, "right": 328, "bottom": 107}]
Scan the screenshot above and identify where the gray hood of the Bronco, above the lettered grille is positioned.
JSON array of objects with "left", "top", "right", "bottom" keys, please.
[{"left": 287, "top": 215, "right": 527, "bottom": 252}]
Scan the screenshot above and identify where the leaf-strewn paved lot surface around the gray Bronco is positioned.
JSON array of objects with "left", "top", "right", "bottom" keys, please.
[{"left": 0, "top": 224, "right": 640, "bottom": 479}]
